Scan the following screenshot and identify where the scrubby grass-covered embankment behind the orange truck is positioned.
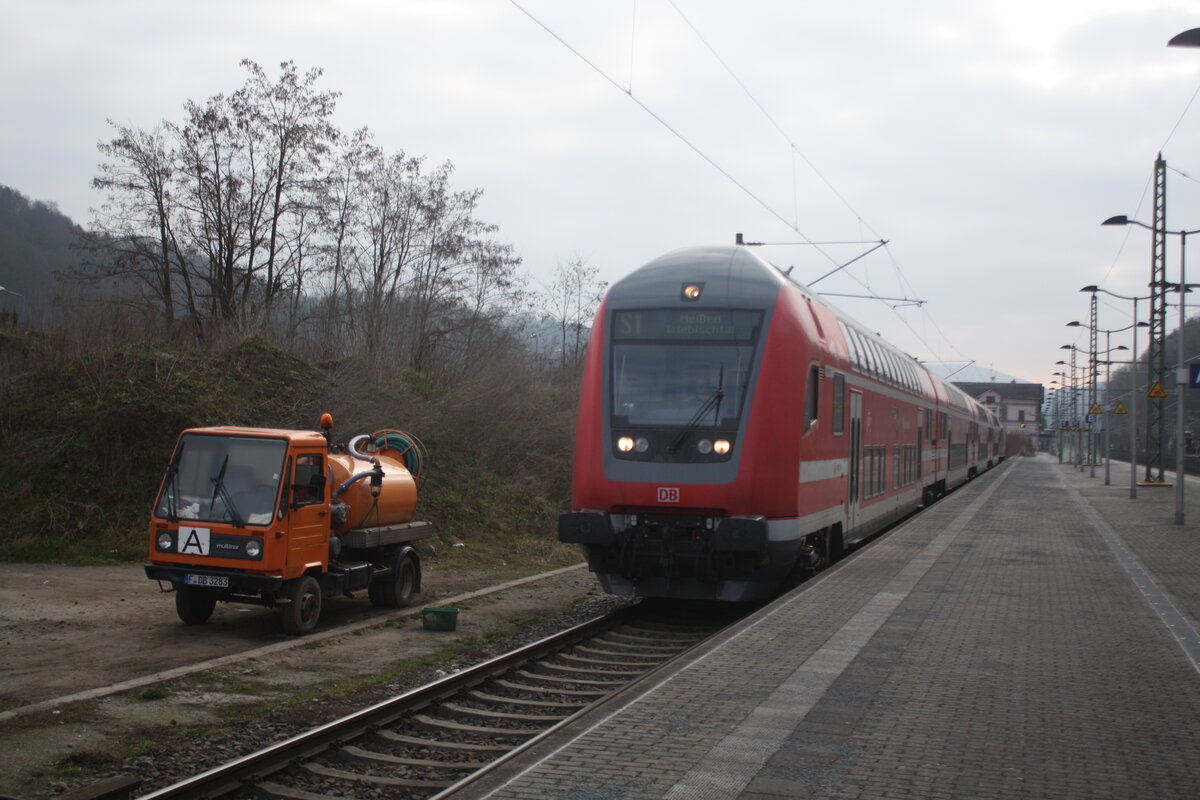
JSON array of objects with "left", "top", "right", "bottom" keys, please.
[{"left": 0, "top": 329, "right": 578, "bottom": 572}]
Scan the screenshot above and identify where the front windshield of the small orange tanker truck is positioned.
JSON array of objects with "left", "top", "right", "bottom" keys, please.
[{"left": 155, "top": 433, "right": 287, "bottom": 525}]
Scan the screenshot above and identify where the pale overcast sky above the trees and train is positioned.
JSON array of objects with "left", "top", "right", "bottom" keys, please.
[{"left": 7, "top": 0, "right": 1200, "bottom": 381}]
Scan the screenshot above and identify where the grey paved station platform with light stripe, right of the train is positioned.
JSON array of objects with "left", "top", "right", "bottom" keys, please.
[{"left": 454, "top": 456, "right": 1200, "bottom": 800}]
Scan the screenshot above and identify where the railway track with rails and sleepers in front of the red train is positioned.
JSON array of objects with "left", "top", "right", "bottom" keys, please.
[{"left": 126, "top": 602, "right": 734, "bottom": 800}]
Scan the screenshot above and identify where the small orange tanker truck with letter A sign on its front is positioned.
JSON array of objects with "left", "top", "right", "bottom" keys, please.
[{"left": 145, "top": 414, "right": 433, "bottom": 634}]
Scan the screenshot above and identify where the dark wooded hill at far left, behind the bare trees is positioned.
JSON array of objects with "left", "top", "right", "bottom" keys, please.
[{"left": 0, "top": 186, "right": 83, "bottom": 317}]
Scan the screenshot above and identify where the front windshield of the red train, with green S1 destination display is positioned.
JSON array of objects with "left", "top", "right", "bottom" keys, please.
[{"left": 612, "top": 311, "right": 762, "bottom": 428}]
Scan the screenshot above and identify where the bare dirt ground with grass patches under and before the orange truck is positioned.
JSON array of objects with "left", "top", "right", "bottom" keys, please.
[{"left": 0, "top": 565, "right": 601, "bottom": 798}]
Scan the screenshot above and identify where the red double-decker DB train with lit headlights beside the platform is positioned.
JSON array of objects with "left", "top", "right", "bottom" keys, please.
[{"left": 558, "top": 247, "right": 1004, "bottom": 601}]
